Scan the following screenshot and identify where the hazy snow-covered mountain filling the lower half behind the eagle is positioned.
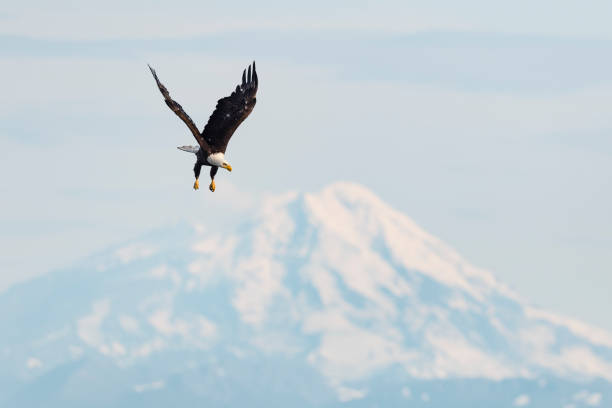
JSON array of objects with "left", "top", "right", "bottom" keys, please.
[{"left": 0, "top": 183, "right": 612, "bottom": 408}]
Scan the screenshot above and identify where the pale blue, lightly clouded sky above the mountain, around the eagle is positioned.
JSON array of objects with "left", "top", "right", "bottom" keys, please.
[{"left": 0, "top": 1, "right": 612, "bottom": 329}]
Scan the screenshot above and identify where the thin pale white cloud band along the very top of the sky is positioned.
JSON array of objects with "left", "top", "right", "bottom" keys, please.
[{"left": 0, "top": 0, "right": 612, "bottom": 40}]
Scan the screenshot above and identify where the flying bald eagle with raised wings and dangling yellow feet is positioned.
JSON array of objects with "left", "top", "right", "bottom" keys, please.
[{"left": 149, "top": 61, "right": 258, "bottom": 192}]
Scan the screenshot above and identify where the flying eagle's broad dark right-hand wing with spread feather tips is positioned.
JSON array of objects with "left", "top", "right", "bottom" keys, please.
[{"left": 202, "top": 61, "right": 258, "bottom": 153}]
